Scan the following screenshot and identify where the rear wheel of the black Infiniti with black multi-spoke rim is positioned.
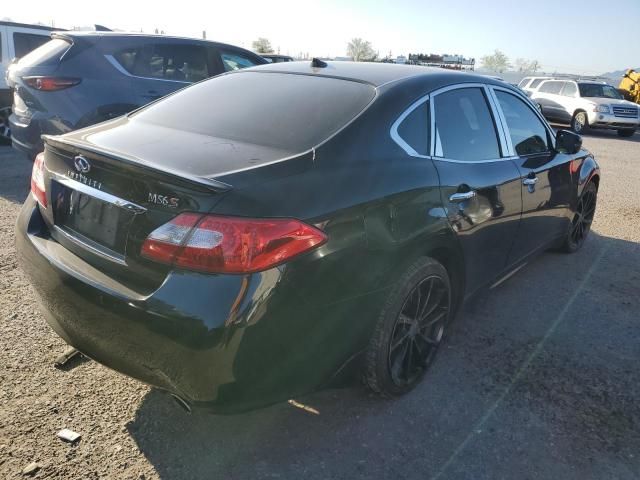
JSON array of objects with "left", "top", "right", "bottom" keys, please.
[{"left": 364, "top": 257, "right": 452, "bottom": 398}]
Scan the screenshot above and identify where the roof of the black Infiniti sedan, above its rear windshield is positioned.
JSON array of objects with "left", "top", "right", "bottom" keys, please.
[{"left": 242, "top": 60, "right": 505, "bottom": 87}]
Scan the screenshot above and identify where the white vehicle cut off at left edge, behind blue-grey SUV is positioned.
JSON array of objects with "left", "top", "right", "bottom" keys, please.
[{"left": 0, "top": 21, "right": 59, "bottom": 143}]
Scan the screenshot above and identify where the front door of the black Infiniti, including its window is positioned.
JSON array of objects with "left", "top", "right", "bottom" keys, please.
[{"left": 491, "top": 86, "right": 575, "bottom": 263}]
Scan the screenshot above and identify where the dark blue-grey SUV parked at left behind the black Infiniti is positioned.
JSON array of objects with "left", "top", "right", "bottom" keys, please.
[{"left": 8, "top": 32, "right": 267, "bottom": 158}]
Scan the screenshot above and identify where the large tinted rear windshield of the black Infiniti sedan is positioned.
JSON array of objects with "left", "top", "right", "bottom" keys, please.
[{"left": 132, "top": 71, "right": 375, "bottom": 153}]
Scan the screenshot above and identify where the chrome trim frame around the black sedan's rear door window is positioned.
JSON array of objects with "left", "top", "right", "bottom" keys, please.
[{"left": 429, "top": 83, "right": 514, "bottom": 163}]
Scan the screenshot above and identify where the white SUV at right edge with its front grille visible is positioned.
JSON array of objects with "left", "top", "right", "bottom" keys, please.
[{"left": 531, "top": 80, "right": 640, "bottom": 137}]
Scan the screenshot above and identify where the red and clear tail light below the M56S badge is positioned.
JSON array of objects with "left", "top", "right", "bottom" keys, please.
[{"left": 142, "top": 213, "right": 327, "bottom": 273}]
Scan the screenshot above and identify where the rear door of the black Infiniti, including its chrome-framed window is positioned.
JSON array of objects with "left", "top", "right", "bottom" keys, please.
[{"left": 430, "top": 84, "right": 522, "bottom": 293}]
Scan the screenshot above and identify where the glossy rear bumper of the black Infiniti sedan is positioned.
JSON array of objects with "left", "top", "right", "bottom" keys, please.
[{"left": 16, "top": 198, "right": 384, "bottom": 413}]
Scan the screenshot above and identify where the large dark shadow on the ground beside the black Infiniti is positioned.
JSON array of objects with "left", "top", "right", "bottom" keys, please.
[{"left": 127, "top": 232, "right": 640, "bottom": 479}]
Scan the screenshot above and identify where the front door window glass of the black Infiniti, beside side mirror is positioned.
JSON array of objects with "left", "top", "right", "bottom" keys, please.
[{"left": 496, "top": 91, "right": 549, "bottom": 155}]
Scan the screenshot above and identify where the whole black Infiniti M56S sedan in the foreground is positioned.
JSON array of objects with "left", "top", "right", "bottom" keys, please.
[{"left": 17, "top": 60, "right": 600, "bottom": 412}]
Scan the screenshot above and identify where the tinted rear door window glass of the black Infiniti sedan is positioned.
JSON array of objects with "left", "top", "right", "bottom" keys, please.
[{"left": 434, "top": 88, "right": 500, "bottom": 162}]
